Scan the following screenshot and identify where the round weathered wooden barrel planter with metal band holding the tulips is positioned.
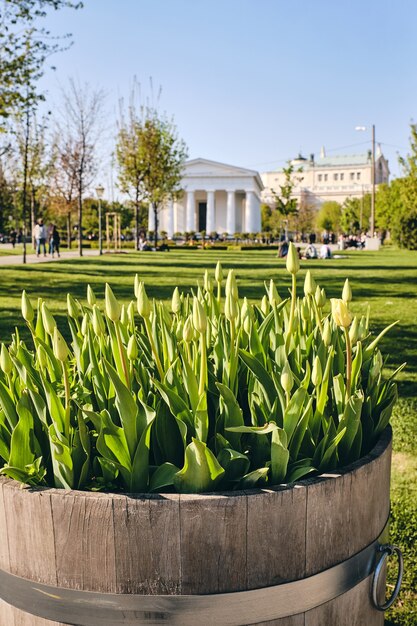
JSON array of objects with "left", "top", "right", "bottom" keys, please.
[{"left": 0, "top": 428, "right": 391, "bottom": 626}]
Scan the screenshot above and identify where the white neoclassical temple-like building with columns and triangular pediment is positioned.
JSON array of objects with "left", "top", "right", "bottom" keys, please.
[{"left": 149, "top": 158, "right": 264, "bottom": 237}]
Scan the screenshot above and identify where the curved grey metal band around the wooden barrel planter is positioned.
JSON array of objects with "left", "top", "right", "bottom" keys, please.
[{"left": 0, "top": 522, "right": 388, "bottom": 626}]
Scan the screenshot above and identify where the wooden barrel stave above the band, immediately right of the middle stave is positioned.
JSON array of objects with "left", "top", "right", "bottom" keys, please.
[{"left": 247, "top": 486, "right": 307, "bottom": 589}]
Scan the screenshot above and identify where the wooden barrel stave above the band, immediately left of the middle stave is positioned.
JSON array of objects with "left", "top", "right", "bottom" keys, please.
[{"left": 113, "top": 495, "right": 181, "bottom": 595}]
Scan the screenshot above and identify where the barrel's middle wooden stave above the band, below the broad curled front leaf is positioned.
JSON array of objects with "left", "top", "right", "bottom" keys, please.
[{"left": 180, "top": 493, "right": 247, "bottom": 594}]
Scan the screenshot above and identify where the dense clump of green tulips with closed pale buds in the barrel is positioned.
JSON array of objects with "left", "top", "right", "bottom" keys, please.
[{"left": 0, "top": 245, "right": 401, "bottom": 493}]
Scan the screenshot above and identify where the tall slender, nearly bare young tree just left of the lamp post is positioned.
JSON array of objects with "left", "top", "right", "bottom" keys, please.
[{"left": 54, "top": 79, "right": 104, "bottom": 256}]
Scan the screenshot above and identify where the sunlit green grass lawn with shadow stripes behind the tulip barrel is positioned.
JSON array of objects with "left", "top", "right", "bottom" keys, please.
[{"left": 0, "top": 249, "right": 417, "bottom": 626}]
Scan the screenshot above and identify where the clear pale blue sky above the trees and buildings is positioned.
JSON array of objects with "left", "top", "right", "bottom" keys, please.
[{"left": 38, "top": 0, "right": 417, "bottom": 188}]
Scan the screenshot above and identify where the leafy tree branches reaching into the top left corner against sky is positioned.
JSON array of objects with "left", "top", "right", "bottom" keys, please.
[{"left": 0, "top": 0, "right": 82, "bottom": 124}]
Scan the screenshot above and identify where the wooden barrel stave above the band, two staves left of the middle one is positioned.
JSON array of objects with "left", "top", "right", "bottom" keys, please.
[{"left": 52, "top": 490, "right": 116, "bottom": 592}]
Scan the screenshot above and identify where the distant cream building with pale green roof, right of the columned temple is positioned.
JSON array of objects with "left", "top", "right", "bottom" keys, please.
[{"left": 261, "top": 145, "right": 390, "bottom": 208}]
